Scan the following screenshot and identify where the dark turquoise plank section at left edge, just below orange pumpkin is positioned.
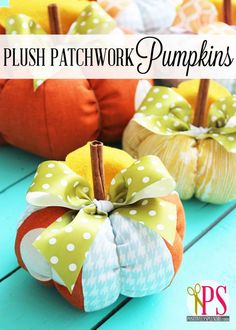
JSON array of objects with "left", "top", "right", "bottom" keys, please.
[{"left": 0, "top": 146, "right": 42, "bottom": 193}]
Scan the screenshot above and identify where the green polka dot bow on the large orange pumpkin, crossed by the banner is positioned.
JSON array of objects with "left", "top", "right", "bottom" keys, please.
[{"left": 6, "top": 2, "right": 117, "bottom": 90}]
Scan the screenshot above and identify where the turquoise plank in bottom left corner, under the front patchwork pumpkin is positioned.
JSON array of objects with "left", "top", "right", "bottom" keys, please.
[{"left": 0, "top": 269, "right": 127, "bottom": 330}]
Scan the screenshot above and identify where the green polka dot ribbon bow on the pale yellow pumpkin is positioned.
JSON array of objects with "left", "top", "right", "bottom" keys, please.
[{"left": 134, "top": 87, "right": 236, "bottom": 153}]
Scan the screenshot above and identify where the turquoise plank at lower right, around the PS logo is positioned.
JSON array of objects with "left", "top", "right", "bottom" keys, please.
[{"left": 100, "top": 210, "right": 236, "bottom": 330}]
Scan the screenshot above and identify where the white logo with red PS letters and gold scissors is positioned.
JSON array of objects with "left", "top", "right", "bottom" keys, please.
[{"left": 187, "top": 281, "right": 230, "bottom": 322}]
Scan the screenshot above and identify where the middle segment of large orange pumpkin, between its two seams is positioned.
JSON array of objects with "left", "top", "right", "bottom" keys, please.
[{"left": 45, "top": 80, "right": 99, "bottom": 159}]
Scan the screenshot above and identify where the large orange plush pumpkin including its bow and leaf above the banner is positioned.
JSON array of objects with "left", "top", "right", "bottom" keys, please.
[{"left": 0, "top": 1, "right": 148, "bottom": 159}]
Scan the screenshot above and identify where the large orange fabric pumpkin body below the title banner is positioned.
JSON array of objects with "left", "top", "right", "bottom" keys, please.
[{"left": 0, "top": 80, "right": 142, "bottom": 159}]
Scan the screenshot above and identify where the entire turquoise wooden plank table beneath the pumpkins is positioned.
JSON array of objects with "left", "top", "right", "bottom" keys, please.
[{"left": 0, "top": 146, "right": 236, "bottom": 330}]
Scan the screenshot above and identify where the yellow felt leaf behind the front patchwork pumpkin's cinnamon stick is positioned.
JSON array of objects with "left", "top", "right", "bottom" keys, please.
[{"left": 66, "top": 143, "right": 134, "bottom": 192}]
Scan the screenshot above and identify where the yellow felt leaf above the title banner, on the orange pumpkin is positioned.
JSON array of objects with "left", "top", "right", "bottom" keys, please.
[{"left": 0, "top": 0, "right": 89, "bottom": 33}]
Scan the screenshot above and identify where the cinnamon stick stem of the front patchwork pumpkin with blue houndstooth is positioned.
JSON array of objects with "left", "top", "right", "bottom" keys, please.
[{"left": 90, "top": 141, "right": 106, "bottom": 200}]
